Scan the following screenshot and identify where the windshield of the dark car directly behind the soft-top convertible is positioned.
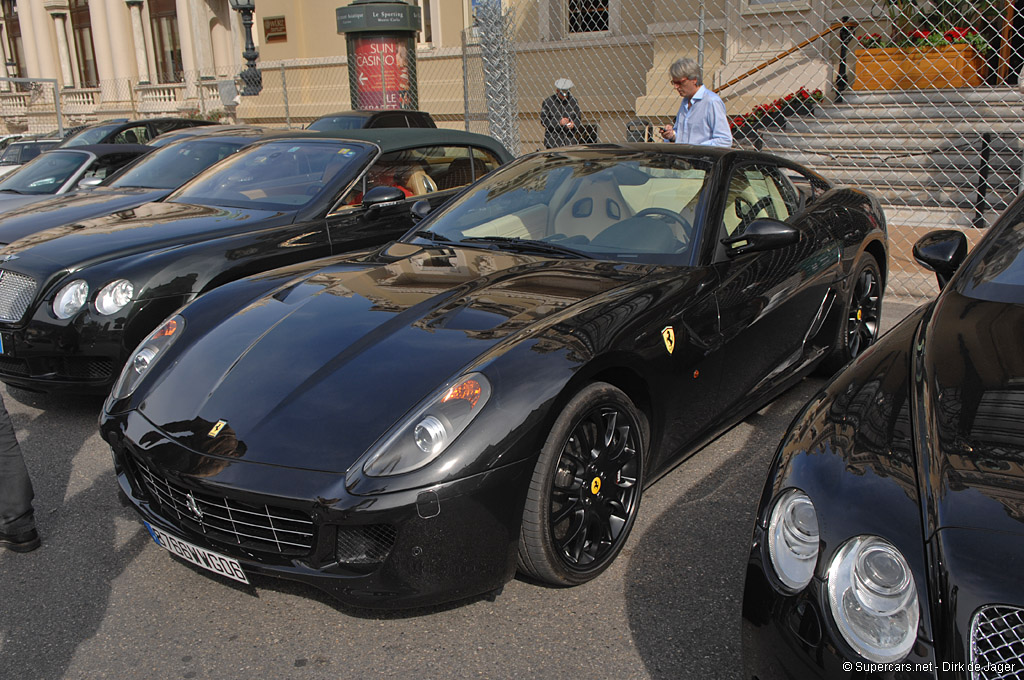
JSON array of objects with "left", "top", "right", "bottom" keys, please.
[{"left": 110, "top": 139, "right": 250, "bottom": 188}]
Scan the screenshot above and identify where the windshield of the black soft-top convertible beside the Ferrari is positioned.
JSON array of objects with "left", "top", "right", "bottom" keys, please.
[{"left": 168, "top": 139, "right": 376, "bottom": 210}]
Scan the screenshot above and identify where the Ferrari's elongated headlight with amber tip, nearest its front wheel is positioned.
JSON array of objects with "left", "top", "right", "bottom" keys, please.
[{"left": 362, "top": 373, "right": 490, "bottom": 477}]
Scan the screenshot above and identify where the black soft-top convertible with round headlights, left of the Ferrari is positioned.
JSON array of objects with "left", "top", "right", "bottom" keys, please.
[{"left": 0, "top": 129, "right": 510, "bottom": 394}]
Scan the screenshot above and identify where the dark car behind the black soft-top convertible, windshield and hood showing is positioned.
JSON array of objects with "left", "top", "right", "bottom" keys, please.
[{"left": 0, "top": 128, "right": 263, "bottom": 246}]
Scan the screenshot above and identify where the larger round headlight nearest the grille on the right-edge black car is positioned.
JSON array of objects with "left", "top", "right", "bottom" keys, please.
[{"left": 828, "top": 536, "right": 920, "bottom": 664}]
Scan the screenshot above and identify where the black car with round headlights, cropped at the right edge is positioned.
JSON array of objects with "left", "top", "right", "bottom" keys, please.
[{"left": 743, "top": 188, "right": 1024, "bottom": 680}]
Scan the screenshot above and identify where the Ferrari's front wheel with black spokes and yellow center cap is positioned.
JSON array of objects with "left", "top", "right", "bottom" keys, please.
[{"left": 518, "top": 382, "right": 648, "bottom": 586}]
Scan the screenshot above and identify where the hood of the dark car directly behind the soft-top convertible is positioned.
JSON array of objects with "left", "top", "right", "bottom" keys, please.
[{"left": 0, "top": 186, "right": 170, "bottom": 244}]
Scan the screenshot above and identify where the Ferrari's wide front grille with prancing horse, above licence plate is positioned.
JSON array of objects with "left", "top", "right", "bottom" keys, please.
[{"left": 133, "top": 458, "right": 313, "bottom": 555}]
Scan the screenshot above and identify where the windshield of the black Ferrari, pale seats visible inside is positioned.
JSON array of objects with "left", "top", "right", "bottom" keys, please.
[{"left": 414, "top": 152, "right": 712, "bottom": 264}]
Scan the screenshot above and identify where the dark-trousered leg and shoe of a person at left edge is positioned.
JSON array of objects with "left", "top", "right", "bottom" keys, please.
[{"left": 0, "top": 397, "right": 39, "bottom": 552}]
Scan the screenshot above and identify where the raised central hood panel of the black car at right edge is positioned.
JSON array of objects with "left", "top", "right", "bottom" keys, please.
[{"left": 924, "top": 290, "right": 1024, "bottom": 534}]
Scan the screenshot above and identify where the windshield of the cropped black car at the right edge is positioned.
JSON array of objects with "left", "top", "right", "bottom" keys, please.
[{"left": 957, "top": 201, "right": 1024, "bottom": 303}]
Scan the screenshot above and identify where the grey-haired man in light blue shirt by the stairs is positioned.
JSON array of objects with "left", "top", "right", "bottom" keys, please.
[{"left": 662, "top": 57, "right": 732, "bottom": 146}]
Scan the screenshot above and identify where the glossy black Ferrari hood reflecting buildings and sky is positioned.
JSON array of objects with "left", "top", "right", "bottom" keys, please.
[{"left": 139, "top": 246, "right": 647, "bottom": 473}]
